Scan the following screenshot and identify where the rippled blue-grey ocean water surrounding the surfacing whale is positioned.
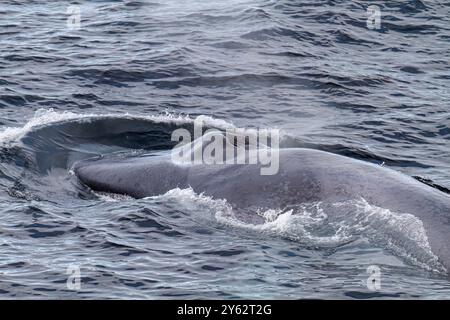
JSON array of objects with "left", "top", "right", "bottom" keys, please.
[{"left": 0, "top": 0, "right": 450, "bottom": 299}]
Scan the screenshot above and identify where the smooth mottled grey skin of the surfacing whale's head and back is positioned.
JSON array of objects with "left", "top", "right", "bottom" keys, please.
[{"left": 74, "top": 148, "right": 450, "bottom": 271}]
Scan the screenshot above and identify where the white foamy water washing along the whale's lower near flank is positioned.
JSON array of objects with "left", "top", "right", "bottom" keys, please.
[{"left": 149, "top": 188, "right": 446, "bottom": 272}]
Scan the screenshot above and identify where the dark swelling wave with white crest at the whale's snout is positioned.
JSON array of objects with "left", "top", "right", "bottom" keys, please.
[{"left": 0, "top": 109, "right": 233, "bottom": 200}]
